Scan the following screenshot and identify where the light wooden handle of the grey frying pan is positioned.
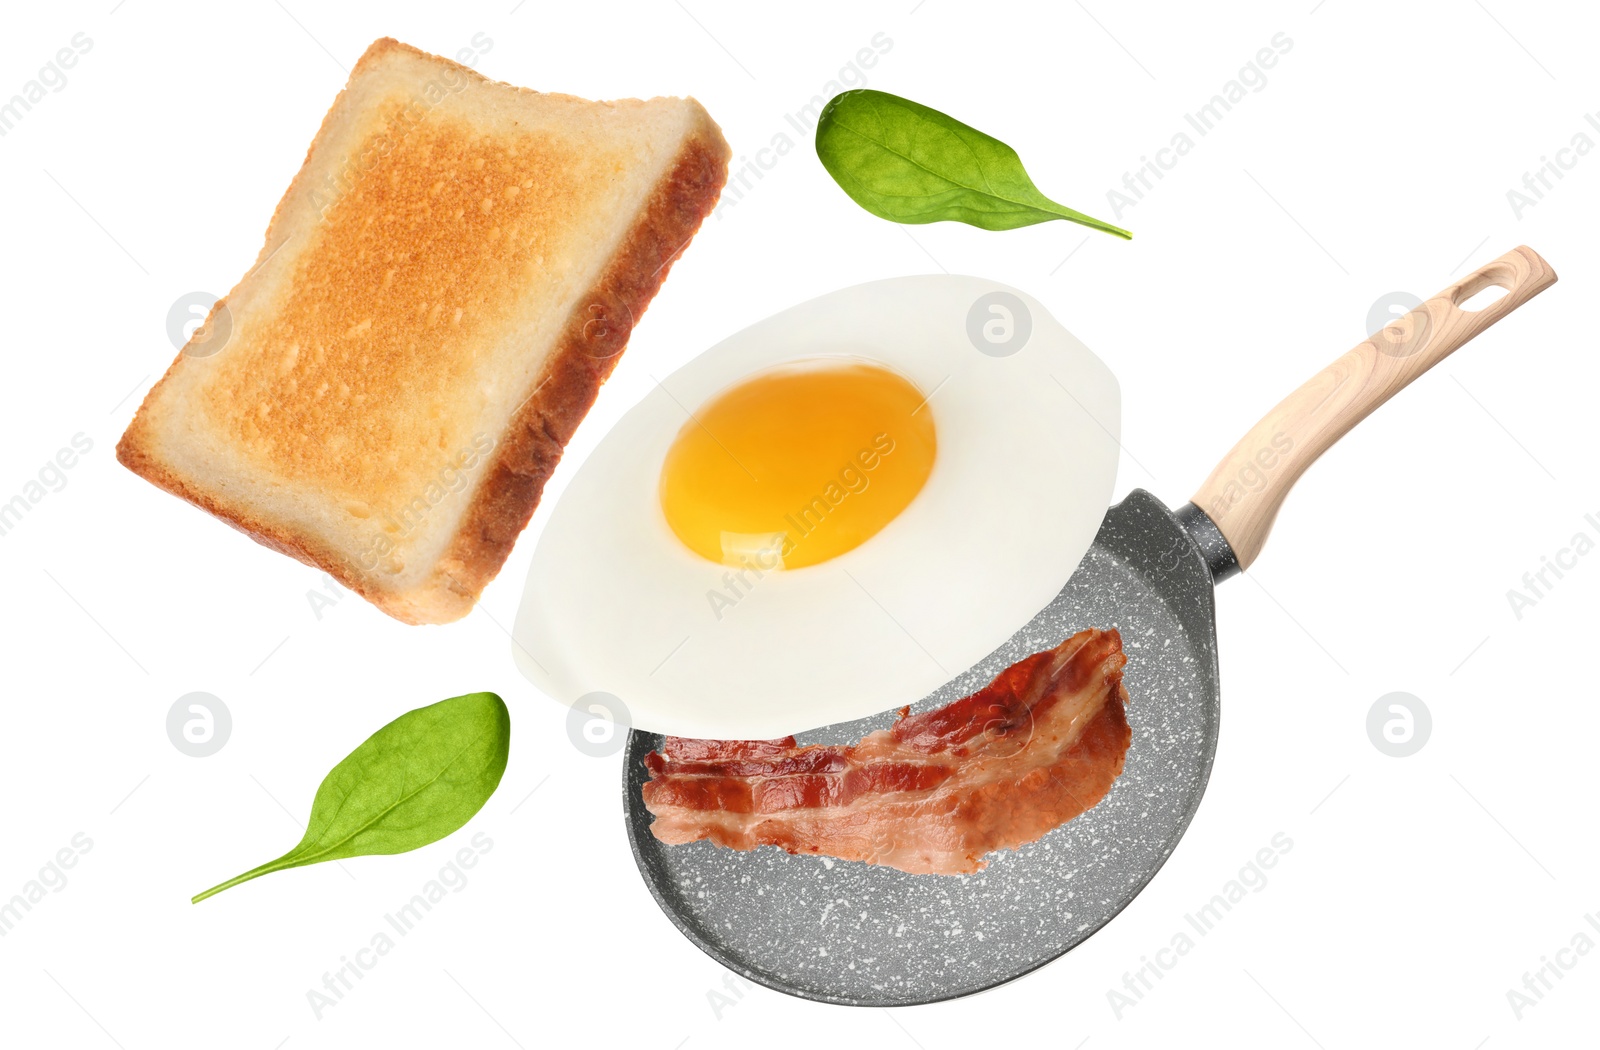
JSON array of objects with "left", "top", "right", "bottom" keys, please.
[{"left": 1194, "top": 246, "right": 1555, "bottom": 568}]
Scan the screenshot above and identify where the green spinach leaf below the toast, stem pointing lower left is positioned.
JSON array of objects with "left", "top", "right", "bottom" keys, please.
[{"left": 194, "top": 693, "right": 510, "bottom": 903}]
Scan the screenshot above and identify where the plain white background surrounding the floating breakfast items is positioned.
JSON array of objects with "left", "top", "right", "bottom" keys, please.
[{"left": 0, "top": 0, "right": 1600, "bottom": 1050}]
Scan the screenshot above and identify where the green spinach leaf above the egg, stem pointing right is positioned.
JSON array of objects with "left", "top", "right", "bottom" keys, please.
[{"left": 816, "top": 88, "right": 1133, "bottom": 238}]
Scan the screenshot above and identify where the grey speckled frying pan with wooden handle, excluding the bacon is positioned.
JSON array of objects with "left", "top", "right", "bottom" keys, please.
[{"left": 622, "top": 246, "right": 1555, "bottom": 1007}]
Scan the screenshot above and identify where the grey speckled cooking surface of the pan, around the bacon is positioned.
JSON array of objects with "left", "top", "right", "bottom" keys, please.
[{"left": 624, "top": 490, "right": 1219, "bottom": 1005}]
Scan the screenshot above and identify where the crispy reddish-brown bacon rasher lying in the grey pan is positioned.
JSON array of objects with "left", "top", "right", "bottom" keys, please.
[{"left": 645, "top": 629, "right": 1131, "bottom": 876}]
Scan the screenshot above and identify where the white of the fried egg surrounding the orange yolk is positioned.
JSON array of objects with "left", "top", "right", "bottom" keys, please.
[{"left": 512, "top": 275, "right": 1120, "bottom": 739}]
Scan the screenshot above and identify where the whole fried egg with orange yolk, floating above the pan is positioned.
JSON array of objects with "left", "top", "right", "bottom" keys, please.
[{"left": 512, "top": 275, "right": 1120, "bottom": 739}]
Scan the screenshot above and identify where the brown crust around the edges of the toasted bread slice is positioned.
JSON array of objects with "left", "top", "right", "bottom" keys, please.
[{"left": 117, "top": 38, "right": 730, "bottom": 624}]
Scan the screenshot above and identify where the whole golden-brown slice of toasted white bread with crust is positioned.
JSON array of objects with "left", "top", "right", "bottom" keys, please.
[{"left": 117, "top": 40, "right": 728, "bottom": 623}]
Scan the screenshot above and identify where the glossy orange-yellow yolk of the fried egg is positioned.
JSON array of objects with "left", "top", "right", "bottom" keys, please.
[{"left": 661, "top": 360, "right": 938, "bottom": 571}]
